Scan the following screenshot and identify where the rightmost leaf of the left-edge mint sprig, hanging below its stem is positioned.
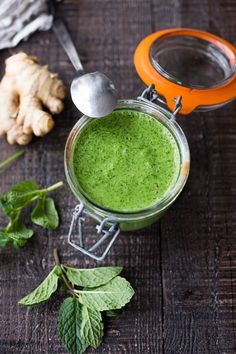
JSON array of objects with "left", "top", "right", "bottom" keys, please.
[{"left": 31, "top": 198, "right": 59, "bottom": 230}]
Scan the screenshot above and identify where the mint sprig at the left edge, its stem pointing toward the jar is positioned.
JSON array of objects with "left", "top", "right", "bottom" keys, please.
[{"left": 0, "top": 180, "right": 63, "bottom": 247}]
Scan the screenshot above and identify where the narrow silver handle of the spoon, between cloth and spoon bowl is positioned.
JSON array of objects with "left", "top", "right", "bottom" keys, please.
[{"left": 52, "top": 16, "right": 84, "bottom": 74}]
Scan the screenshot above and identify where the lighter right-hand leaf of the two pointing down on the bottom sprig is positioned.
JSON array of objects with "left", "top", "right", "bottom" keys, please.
[{"left": 80, "top": 306, "right": 103, "bottom": 348}]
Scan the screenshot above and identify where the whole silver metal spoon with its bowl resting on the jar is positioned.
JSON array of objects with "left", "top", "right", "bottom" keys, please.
[{"left": 53, "top": 15, "right": 117, "bottom": 118}]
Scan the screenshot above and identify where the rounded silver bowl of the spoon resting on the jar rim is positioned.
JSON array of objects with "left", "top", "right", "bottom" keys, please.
[{"left": 71, "top": 71, "right": 117, "bottom": 118}]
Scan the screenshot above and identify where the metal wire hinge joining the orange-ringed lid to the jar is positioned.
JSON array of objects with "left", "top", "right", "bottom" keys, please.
[{"left": 138, "top": 84, "right": 182, "bottom": 120}]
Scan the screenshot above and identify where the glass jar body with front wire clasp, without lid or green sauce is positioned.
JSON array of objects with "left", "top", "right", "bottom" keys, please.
[{"left": 65, "top": 97, "right": 190, "bottom": 259}]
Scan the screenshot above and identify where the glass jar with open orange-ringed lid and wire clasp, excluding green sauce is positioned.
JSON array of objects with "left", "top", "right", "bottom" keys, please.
[{"left": 65, "top": 28, "right": 236, "bottom": 260}]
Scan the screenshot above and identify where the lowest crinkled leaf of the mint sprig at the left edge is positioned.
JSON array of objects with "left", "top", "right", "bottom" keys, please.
[{"left": 3, "top": 218, "right": 34, "bottom": 247}]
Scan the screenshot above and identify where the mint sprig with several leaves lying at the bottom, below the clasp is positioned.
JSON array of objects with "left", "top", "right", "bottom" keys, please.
[{"left": 19, "top": 250, "right": 134, "bottom": 354}]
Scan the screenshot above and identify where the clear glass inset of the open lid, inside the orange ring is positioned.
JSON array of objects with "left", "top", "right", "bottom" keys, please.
[{"left": 150, "top": 32, "right": 236, "bottom": 90}]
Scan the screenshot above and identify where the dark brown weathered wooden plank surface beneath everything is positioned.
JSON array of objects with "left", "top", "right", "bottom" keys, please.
[{"left": 0, "top": 0, "right": 236, "bottom": 354}]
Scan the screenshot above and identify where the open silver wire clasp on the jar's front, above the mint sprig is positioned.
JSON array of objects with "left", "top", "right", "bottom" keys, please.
[{"left": 68, "top": 203, "right": 120, "bottom": 261}]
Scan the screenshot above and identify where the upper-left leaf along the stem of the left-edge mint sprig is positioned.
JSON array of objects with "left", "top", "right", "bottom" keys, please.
[{"left": 0, "top": 180, "right": 39, "bottom": 213}]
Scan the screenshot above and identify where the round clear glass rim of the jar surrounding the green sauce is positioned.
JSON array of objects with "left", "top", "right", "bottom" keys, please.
[{"left": 64, "top": 99, "right": 190, "bottom": 220}]
